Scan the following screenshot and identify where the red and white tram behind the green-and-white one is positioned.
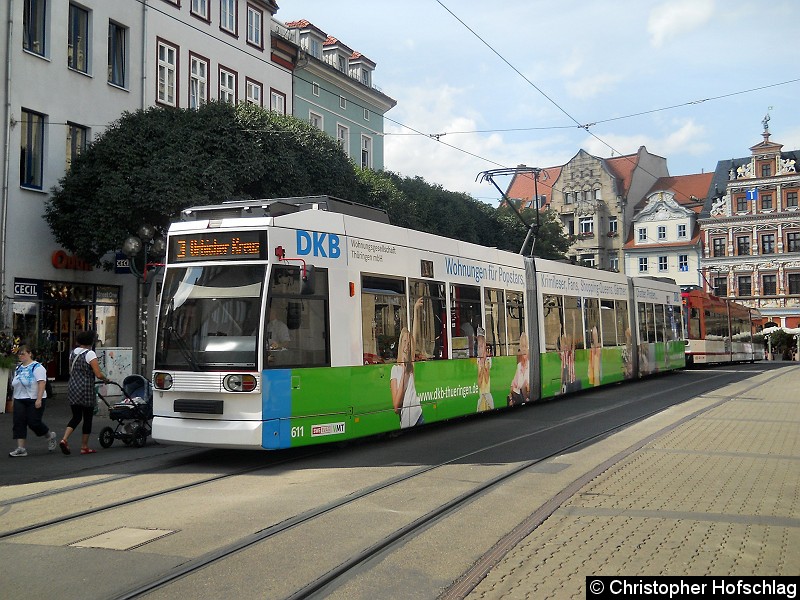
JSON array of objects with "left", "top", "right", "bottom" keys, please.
[{"left": 681, "top": 286, "right": 764, "bottom": 365}]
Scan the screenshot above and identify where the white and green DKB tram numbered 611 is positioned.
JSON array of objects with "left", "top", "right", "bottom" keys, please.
[{"left": 153, "top": 196, "right": 685, "bottom": 450}]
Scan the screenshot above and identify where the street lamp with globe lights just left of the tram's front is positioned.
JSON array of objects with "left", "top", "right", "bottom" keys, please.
[{"left": 122, "top": 224, "right": 167, "bottom": 371}]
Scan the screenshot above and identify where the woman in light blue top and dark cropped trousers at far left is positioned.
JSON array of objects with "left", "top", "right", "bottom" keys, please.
[{"left": 8, "top": 344, "right": 56, "bottom": 458}]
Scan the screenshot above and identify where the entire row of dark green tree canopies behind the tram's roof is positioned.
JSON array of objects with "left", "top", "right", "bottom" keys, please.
[{"left": 45, "top": 102, "right": 569, "bottom": 268}]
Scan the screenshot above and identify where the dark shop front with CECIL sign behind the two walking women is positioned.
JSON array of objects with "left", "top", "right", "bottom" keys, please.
[{"left": 12, "top": 277, "right": 121, "bottom": 380}]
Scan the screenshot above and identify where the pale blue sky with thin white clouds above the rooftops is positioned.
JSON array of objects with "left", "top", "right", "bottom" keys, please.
[{"left": 286, "top": 0, "right": 800, "bottom": 204}]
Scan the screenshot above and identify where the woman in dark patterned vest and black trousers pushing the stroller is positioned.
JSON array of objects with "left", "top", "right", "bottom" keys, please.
[{"left": 58, "top": 331, "right": 109, "bottom": 454}]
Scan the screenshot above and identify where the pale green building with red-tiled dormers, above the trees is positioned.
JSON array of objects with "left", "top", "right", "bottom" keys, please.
[{"left": 286, "top": 20, "right": 397, "bottom": 170}]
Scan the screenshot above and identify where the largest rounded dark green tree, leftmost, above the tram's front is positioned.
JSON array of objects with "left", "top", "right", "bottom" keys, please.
[{"left": 45, "top": 102, "right": 358, "bottom": 268}]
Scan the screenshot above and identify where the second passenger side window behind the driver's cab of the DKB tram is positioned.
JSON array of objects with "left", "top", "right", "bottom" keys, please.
[{"left": 408, "top": 280, "right": 447, "bottom": 360}]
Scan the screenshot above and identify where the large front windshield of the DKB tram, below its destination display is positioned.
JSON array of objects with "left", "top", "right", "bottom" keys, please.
[{"left": 155, "top": 264, "right": 266, "bottom": 371}]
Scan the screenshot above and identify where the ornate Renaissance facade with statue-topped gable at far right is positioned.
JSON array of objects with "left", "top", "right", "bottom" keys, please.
[{"left": 700, "top": 122, "right": 800, "bottom": 328}]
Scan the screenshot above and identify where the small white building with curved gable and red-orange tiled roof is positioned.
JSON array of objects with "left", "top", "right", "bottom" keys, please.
[{"left": 624, "top": 173, "right": 713, "bottom": 286}]
